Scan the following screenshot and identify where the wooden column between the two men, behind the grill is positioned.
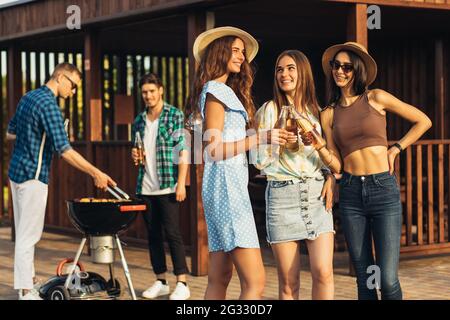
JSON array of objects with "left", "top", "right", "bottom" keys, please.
[{"left": 84, "top": 30, "right": 102, "bottom": 196}]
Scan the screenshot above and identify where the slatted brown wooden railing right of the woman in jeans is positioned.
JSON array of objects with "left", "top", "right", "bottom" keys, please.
[{"left": 395, "top": 140, "right": 450, "bottom": 255}]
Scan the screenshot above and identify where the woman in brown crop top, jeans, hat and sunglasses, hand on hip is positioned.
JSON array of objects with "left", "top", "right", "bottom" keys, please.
[{"left": 306, "top": 42, "right": 431, "bottom": 299}]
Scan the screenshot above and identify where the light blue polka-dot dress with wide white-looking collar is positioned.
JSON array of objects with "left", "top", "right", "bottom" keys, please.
[{"left": 199, "top": 81, "right": 259, "bottom": 252}]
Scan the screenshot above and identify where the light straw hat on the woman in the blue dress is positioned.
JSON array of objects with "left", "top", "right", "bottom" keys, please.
[{"left": 192, "top": 27, "right": 259, "bottom": 62}]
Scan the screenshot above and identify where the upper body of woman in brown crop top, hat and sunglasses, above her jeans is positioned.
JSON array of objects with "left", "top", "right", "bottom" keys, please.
[{"left": 314, "top": 42, "right": 431, "bottom": 176}]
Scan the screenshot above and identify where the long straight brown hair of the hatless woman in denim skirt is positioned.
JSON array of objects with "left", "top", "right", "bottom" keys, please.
[{"left": 273, "top": 50, "right": 320, "bottom": 119}]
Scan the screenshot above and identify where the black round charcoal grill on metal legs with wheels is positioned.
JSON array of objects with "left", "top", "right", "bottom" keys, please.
[{"left": 41, "top": 187, "right": 147, "bottom": 300}]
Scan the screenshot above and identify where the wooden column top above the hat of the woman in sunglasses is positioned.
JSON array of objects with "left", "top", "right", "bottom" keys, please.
[{"left": 347, "top": 3, "right": 368, "bottom": 48}]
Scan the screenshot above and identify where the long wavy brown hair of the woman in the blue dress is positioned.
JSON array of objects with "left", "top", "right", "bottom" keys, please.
[{"left": 186, "top": 36, "right": 255, "bottom": 127}]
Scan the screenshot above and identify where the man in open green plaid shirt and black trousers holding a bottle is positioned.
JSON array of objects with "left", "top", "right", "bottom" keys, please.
[{"left": 132, "top": 74, "right": 190, "bottom": 300}]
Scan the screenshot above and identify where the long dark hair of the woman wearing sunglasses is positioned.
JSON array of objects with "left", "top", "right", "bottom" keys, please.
[{"left": 326, "top": 50, "right": 367, "bottom": 108}]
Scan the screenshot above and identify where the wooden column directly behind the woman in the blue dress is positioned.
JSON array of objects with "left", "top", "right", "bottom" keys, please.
[{"left": 187, "top": 13, "right": 208, "bottom": 276}]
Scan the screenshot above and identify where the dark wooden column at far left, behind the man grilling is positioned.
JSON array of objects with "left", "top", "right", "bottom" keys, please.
[{"left": 6, "top": 45, "right": 22, "bottom": 241}]
